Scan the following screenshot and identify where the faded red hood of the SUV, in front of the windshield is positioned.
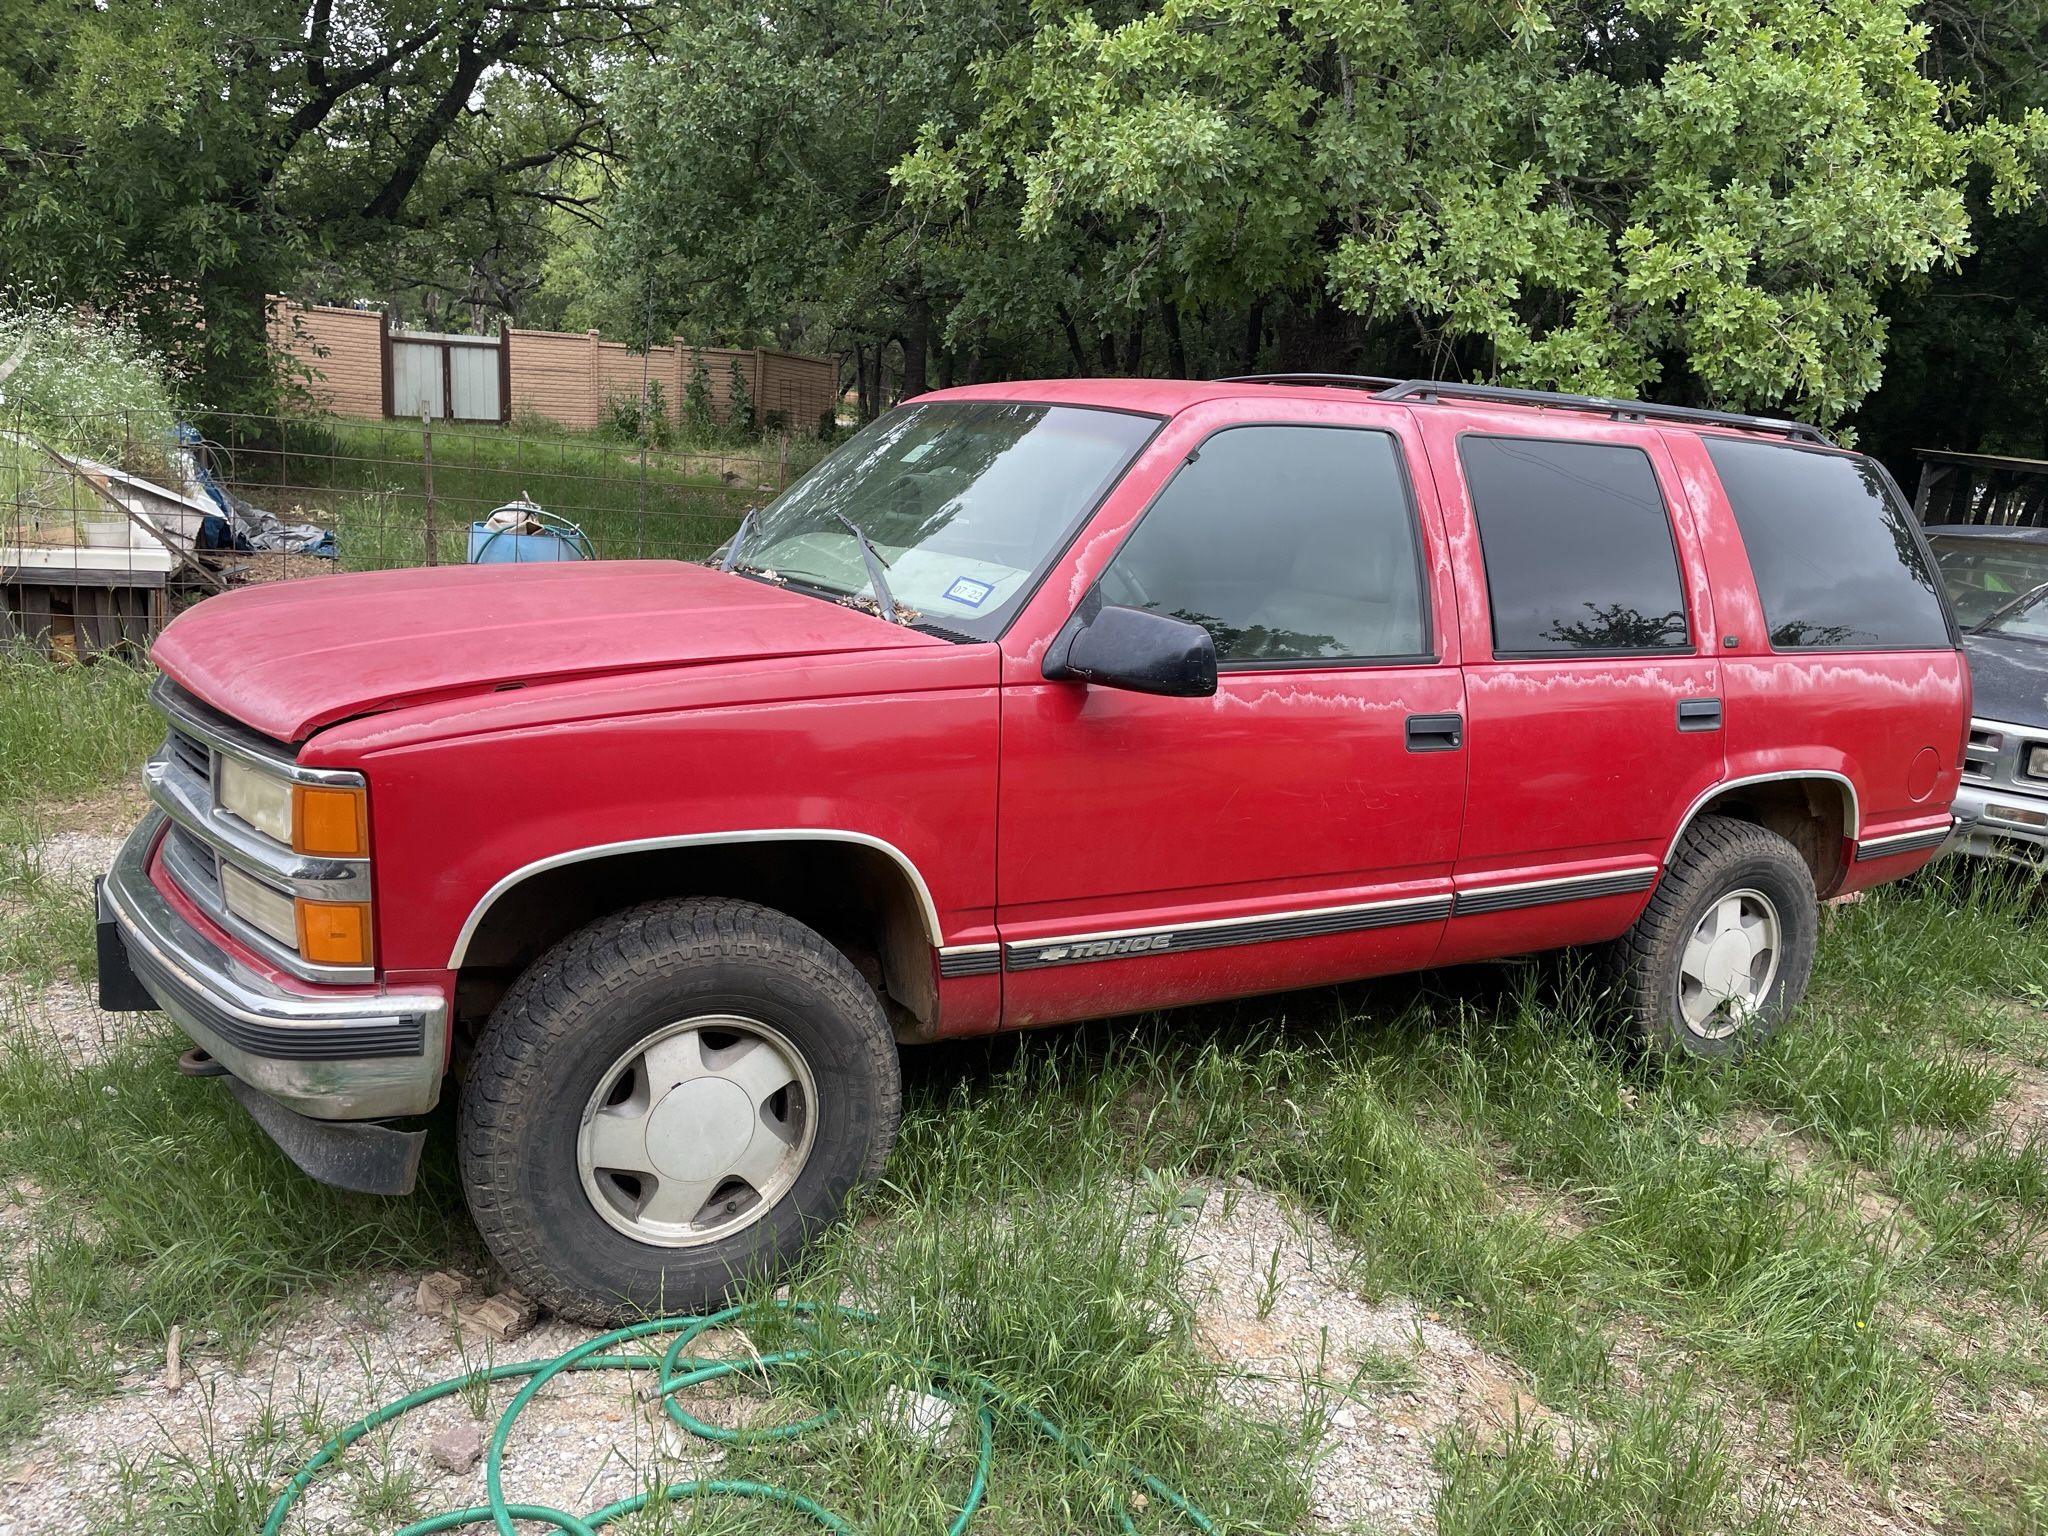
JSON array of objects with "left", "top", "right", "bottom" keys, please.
[{"left": 152, "top": 559, "right": 946, "bottom": 741}]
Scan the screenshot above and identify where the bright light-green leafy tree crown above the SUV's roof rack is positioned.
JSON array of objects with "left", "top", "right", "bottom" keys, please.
[{"left": 897, "top": 0, "right": 2048, "bottom": 420}]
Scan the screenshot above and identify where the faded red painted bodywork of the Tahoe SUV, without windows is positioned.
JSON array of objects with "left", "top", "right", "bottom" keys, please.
[{"left": 136, "top": 379, "right": 1970, "bottom": 1032}]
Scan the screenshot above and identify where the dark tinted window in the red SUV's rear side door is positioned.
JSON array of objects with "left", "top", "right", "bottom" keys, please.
[{"left": 1458, "top": 436, "right": 1688, "bottom": 655}]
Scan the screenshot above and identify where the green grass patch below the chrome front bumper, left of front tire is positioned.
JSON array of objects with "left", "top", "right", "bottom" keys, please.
[{"left": 0, "top": 1011, "right": 473, "bottom": 1391}]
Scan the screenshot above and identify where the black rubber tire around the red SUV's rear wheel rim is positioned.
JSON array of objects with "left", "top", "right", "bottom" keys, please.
[{"left": 1602, "top": 815, "right": 1821, "bottom": 1061}]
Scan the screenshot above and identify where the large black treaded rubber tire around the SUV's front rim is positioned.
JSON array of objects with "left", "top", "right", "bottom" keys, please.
[{"left": 459, "top": 899, "right": 903, "bottom": 1325}]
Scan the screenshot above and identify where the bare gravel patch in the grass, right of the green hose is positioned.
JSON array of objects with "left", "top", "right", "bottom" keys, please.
[{"left": 1184, "top": 1184, "right": 1583, "bottom": 1532}]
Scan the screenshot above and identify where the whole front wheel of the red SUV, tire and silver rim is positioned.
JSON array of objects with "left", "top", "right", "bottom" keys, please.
[{"left": 461, "top": 899, "right": 901, "bottom": 1323}]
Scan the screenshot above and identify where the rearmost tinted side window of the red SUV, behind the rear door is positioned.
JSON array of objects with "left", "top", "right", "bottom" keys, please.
[{"left": 1704, "top": 436, "right": 1950, "bottom": 651}]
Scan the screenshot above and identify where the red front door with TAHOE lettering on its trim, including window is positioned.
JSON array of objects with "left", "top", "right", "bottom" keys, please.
[{"left": 997, "top": 415, "right": 1464, "bottom": 1026}]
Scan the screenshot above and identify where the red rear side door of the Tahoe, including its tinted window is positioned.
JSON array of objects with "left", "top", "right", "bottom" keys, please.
[{"left": 1423, "top": 410, "right": 1722, "bottom": 963}]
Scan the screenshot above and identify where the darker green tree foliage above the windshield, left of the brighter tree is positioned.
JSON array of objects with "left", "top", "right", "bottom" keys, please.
[{"left": 594, "top": 0, "right": 1030, "bottom": 414}]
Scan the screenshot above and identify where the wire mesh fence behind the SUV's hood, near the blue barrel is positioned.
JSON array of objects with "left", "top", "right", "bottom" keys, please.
[{"left": 0, "top": 408, "right": 823, "bottom": 653}]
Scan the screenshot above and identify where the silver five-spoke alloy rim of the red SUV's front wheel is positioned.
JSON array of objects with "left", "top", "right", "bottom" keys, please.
[{"left": 575, "top": 1014, "right": 817, "bottom": 1247}]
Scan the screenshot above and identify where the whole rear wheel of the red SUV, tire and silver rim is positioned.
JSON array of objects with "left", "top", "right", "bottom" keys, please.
[{"left": 1608, "top": 815, "right": 1821, "bottom": 1059}]
